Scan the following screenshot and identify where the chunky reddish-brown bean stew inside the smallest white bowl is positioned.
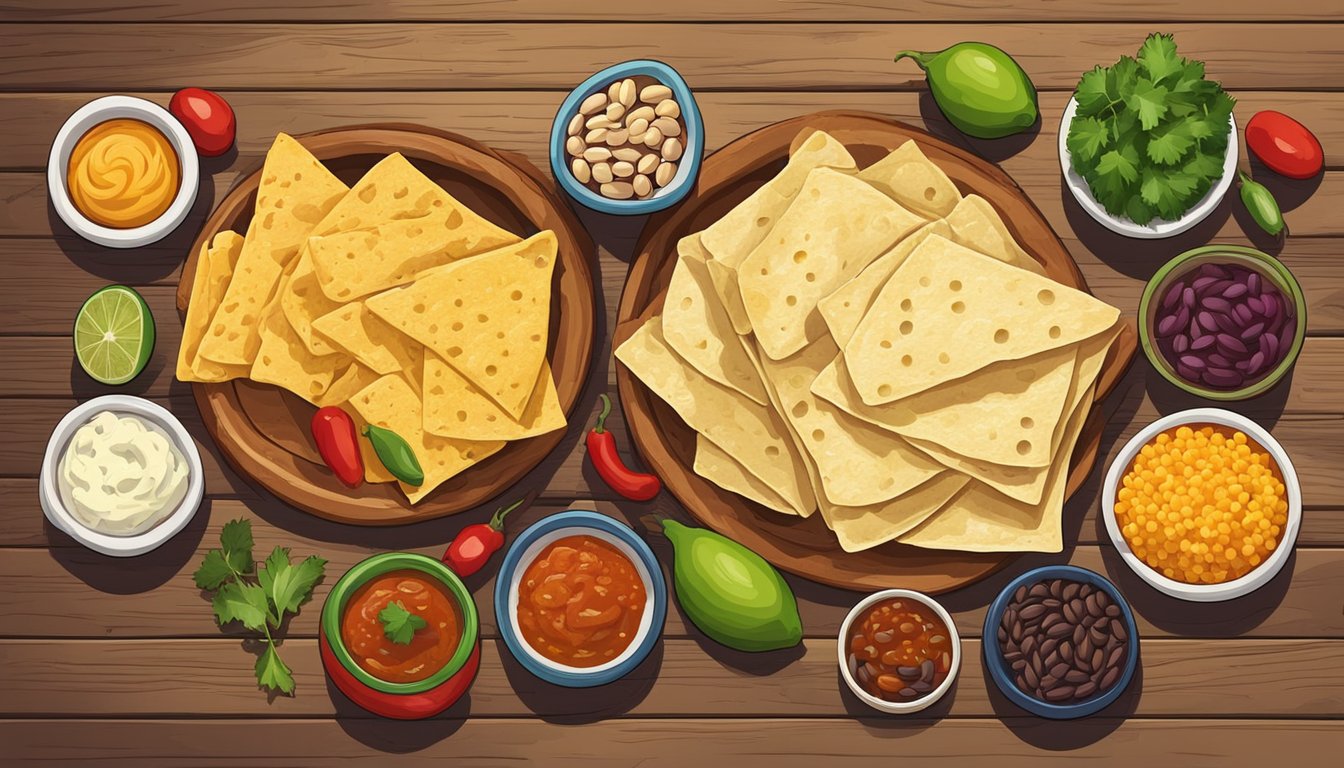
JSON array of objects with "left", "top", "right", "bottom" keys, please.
[{"left": 848, "top": 597, "right": 956, "bottom": 702}]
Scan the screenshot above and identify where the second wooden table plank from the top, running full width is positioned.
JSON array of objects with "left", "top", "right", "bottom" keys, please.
[{"left": 0, "top": 22, "right": 1344, "bottom": 91}]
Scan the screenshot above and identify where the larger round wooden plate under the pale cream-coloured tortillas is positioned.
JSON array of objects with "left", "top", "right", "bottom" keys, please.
[{"left": 613, "top": 112, "right": 1137, "bottom": 593}]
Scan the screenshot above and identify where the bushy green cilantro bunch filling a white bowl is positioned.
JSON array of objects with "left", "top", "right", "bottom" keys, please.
[{"left": 1066, "top": 35, "right": 1236, "bottom": 225}]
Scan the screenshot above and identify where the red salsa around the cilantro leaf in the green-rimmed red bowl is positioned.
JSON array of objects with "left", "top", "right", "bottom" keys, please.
[{"left": 340, "top": 569, "right": 462, "bottom": 683}]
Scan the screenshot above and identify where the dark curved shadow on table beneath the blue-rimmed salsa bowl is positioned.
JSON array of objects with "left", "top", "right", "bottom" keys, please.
[{"left": 500, "top": 639, "right": 663, "bottom": 725}]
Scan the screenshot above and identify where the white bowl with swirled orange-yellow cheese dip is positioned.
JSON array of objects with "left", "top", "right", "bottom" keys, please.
[{"left": 47, "top": 95, "right": 200, "bottom": 247}]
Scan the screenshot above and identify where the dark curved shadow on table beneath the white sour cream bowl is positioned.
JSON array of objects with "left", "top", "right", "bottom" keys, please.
[{"left": 42, "top": 499, "right": 211, "bottom": 594}]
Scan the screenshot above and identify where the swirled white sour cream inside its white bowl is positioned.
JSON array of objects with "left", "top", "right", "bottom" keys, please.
[{"left": 56, "top": 410, "right": 188, "bottom": 535}]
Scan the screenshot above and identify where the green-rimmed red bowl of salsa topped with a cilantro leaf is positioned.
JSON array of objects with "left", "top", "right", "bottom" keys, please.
[{"left": 320, "top": 551, "right": 481, "bottom": 720}]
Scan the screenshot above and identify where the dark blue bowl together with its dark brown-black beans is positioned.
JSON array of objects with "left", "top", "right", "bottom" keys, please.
[{"left": 982, "top": 565, "right": 1138, "bottom": 720}]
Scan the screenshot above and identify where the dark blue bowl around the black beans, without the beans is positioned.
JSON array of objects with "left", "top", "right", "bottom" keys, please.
[{"left": 981, "top": 565, "right": 1138, "bottom": 720}]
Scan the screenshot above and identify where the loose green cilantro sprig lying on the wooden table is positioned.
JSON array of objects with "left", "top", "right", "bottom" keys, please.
[{"left": 194, "top": 519, "right": 327, "bottom": 694}]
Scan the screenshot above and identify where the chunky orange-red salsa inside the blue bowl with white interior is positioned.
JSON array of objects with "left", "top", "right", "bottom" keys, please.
[{"left": 517, "top": 535, "right": 645, "bottom": 667}]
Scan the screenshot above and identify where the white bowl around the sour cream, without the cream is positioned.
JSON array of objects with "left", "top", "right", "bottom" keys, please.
[{"left": 38, "top": 394, "right": 206, "bottom": 557}]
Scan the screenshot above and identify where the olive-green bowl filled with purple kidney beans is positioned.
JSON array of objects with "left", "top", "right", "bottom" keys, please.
[{"left": 1138, "top": 245, "right": 1306, "bottom": 401}]
